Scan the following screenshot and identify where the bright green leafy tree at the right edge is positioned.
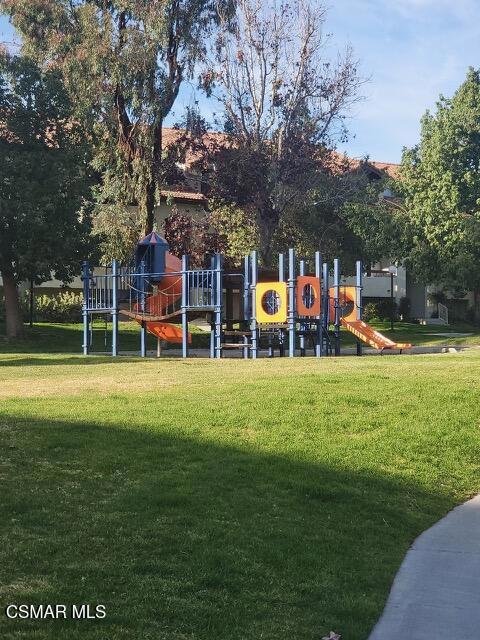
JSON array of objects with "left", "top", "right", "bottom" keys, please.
[{"left": 398, "top": 68, "right": 480, "bottom": 314}]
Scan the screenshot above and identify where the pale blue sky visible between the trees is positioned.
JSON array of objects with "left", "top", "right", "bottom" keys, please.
[{"left": 0, "top": 0, "right": 480, "bottom": 162}]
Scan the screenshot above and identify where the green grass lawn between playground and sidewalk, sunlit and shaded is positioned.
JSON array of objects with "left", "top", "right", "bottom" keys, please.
[{"left": 0, "top": 344, "right": 480, "bottom": 640}]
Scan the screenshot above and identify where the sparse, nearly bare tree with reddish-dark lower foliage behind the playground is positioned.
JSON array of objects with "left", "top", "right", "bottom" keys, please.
[{"left": 202, "top": 0, "right": 360, "bottom": 263}]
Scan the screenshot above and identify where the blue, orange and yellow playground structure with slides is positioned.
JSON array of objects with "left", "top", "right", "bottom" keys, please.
[{"left": 82, "top": 232, "right": 412, "bottom": 358}]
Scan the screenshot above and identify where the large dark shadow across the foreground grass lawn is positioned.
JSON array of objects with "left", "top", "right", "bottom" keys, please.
[{"left": 0, "top": 416, "right": 452, "bottom": 640}]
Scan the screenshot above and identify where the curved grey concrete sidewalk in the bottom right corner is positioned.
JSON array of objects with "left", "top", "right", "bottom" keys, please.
[{"left": 369, "top": 495, "right": 480, "bottom": 640}]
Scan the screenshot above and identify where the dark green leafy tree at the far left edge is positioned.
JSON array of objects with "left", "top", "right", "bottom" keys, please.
[{"left": 0, "top": 53, "right": 90, "bottom": 338}]
